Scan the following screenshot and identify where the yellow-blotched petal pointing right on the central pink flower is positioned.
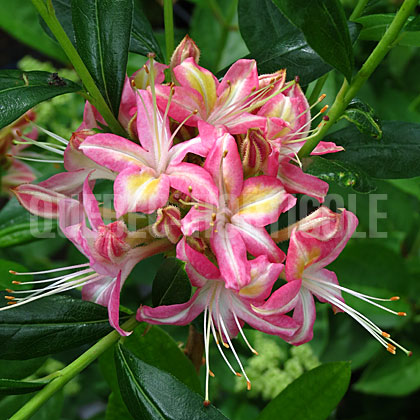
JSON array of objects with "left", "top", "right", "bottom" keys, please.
[{"left": 232, "top": 175, "right": 296, "bottom": 227}]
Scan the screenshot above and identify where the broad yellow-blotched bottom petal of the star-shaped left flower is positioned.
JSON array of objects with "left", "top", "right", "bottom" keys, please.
[{"left": 114, "top": 167, "right": 170, "bottom": 218}]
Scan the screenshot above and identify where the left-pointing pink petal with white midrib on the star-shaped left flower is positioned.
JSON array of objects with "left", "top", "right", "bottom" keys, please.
[{"left": 79, "top": 133, "right": 149, "bottom": 172}]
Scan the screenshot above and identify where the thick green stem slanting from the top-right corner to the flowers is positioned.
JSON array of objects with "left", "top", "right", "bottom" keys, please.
[{"left": 298, "top": 0, "right": 418, "bottom": 159}]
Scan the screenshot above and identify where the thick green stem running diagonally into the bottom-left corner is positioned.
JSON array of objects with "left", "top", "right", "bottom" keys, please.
[{"left": 10, "top": 316, "right": 138, "bottom": 420}]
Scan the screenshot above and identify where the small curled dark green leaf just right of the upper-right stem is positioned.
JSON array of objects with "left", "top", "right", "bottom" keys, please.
[{"left": 342, "top": 98, "right": 382, "bottom": 140}]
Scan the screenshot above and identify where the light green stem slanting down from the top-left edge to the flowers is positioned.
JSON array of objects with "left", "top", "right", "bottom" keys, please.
[{"left": 32, "top": 0, "right": 126, "bottom": 136}]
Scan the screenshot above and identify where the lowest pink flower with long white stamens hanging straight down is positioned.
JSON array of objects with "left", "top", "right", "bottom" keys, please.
[{"left": 137, "top": 239, "right": 297, "bottom": 401}]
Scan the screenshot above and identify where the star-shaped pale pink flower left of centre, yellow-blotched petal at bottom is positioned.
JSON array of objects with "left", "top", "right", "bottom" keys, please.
[{"left": 80, "top": 91, "right": 217, "bottom": 217}]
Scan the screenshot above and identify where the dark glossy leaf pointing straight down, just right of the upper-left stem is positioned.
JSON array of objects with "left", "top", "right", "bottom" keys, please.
[{"left": 71, "top": 0, "right": 133, "bottom": 117}]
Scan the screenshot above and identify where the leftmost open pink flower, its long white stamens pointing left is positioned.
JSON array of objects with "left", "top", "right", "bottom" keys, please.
[{"left": 6, "top": 177, "right": 173, "bottom": 335}]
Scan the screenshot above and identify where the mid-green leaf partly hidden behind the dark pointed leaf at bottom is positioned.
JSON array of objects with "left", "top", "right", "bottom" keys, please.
[{"left": 99, "top": 323, "right": 201, "bottom": 394}]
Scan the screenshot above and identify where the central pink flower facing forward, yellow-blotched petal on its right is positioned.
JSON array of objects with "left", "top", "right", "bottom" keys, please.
[{"left": 182, "top": 134, "right": 296, "bottom": 290}]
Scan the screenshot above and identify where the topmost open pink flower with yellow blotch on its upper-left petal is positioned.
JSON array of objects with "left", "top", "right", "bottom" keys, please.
[{"left": 156, "top": 57, "right": 270, "bottom": 134}]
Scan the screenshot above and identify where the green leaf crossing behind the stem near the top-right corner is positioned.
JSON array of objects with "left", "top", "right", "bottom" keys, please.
[{"left": 355, "top": 13, "right": 420, "bottom": 47}]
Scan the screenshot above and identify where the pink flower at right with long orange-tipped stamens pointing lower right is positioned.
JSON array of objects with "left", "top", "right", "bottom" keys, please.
[{"left": 256, "top": 207, "right": 409, "bottom": 354}]
